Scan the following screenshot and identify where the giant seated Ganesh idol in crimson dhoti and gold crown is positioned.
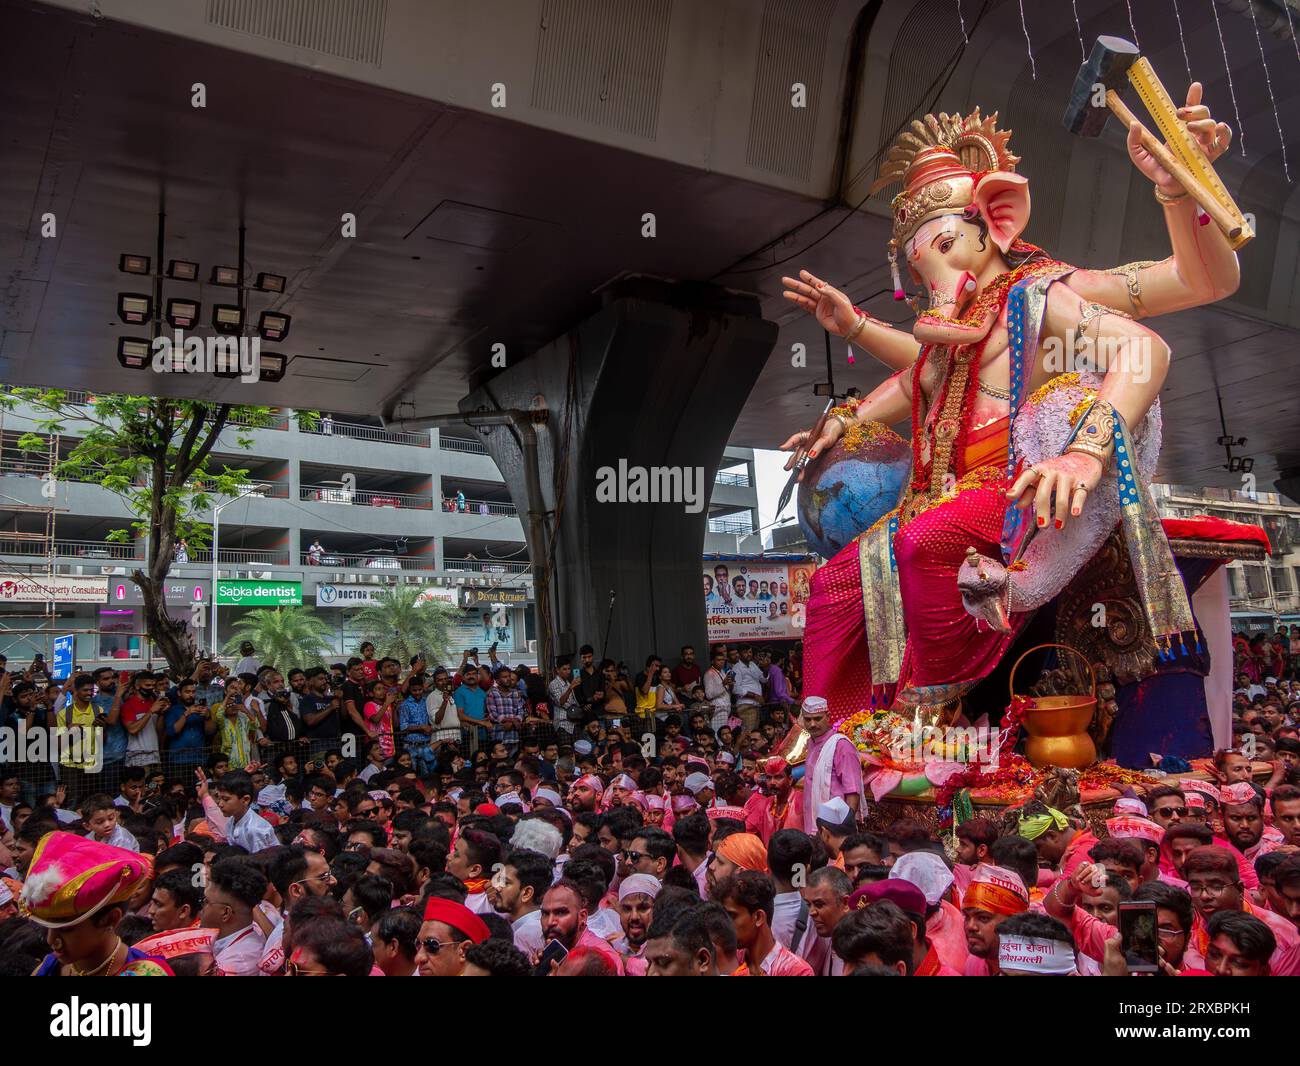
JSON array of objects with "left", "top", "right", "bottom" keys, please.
[{"left": 784, "top": 91, "right": 1239, "bottom": 774}]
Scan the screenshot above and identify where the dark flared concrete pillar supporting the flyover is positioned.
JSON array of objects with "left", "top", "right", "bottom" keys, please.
[{"left": 449, "top": 278, "right": 777, "bottom": 670}]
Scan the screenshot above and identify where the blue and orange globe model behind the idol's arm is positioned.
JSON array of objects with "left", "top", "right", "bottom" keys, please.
[{"left": 798, "top": 423, "right": 911, "bottom": 559}]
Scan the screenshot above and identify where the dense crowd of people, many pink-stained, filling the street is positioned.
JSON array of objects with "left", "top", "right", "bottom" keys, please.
[{"left": 0, "top": 637, "right": 1300, "bottom": 976}]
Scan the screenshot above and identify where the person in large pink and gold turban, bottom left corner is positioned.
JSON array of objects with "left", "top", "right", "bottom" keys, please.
[{"left": 18, "top": 832, "right": 173, "bottom": 978}]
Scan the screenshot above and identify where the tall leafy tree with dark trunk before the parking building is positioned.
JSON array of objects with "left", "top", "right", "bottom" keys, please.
[{"left": 0, "top": 389, "right": 317, "bottom": 676}]
